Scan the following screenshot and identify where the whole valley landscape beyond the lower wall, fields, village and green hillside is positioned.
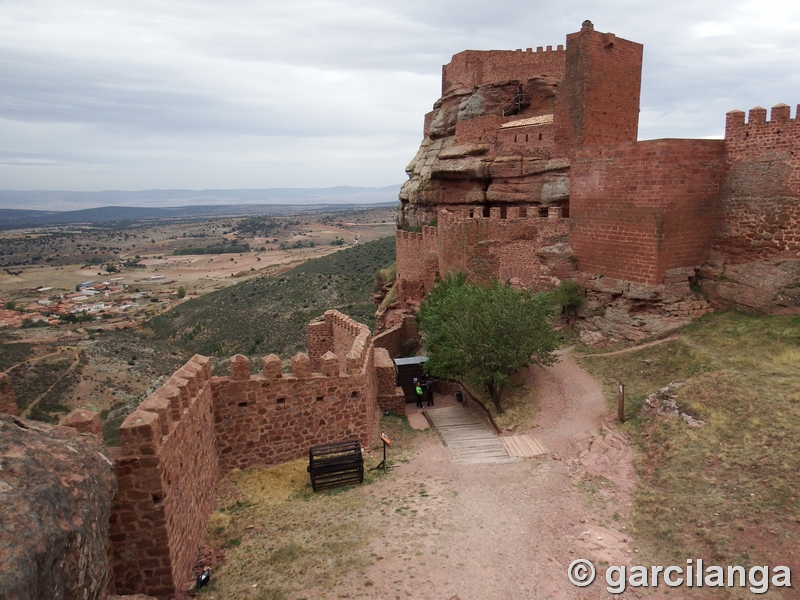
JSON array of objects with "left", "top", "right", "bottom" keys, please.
[{"left": 0, "top": 208, "right": 395, "bottom": 436}]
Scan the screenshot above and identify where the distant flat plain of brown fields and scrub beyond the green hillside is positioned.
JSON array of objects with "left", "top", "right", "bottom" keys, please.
[{"left": 0, "top": 207, "right": 395, "bottom": 302}]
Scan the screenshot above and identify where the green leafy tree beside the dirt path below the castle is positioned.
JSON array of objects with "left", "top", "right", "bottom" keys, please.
[{"left": 417, "top": 273, "right": 559, "bottom": 413}]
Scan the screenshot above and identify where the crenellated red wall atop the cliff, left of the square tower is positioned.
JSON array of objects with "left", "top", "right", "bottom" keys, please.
[{"left": 442, "top": 45, "right": 565, "bottom": 94}]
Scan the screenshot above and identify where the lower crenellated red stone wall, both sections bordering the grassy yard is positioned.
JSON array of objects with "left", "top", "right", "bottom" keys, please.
[{"left": 109, "top": 311, "right": 384, "bottom": 600}]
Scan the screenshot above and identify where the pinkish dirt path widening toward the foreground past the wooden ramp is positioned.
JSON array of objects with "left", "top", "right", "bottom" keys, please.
[{"left": 338, "top": 354, "right": 668, "bottom": 600}]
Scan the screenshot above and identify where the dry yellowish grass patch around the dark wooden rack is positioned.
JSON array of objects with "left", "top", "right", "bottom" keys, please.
[{"left": 202, "top": 415, "right": 424, "bottom": 600}]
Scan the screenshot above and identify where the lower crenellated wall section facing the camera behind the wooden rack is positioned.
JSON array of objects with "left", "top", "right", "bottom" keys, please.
[{"left": 212, "top": 310, "right": 379, "bottom": 473}]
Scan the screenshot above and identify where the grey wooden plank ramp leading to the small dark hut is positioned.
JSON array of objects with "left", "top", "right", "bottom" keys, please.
[{"left": 424, "top": 406, "right": 521, "bottom": 464}]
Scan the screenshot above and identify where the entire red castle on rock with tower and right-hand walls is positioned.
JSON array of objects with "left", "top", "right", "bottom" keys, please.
[{"left": 397, "top": 21, "right": 800, "bottom": 343}]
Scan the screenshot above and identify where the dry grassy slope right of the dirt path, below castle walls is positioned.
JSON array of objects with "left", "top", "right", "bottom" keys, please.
[{"left": 582, "top": 313, "right": 800, "bottom": 566}]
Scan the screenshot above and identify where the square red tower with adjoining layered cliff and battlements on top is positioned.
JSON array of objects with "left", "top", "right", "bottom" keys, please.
[{"left": 398, "top": 21, "right": 642, "bottom": 228}]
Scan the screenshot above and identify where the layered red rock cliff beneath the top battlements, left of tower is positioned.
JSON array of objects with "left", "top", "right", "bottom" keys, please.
[{"left": 397, "top": 77, "right": 569, "bottom": 228}]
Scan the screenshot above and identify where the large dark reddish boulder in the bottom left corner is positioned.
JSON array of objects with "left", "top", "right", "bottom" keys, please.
[{"left": 0, "top": 415, "right": 116, "bottom": 600}]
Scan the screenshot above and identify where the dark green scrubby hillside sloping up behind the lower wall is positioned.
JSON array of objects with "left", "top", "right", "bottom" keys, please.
[{"left": 148, "top": 237, "right": 395, "bottom": 358}]
